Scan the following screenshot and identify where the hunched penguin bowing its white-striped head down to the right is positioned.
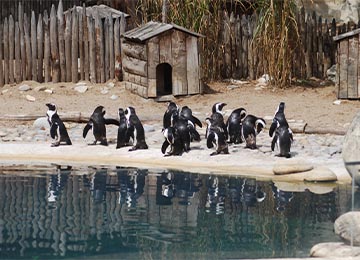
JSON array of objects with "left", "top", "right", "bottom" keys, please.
[{"left": 241, "top": 115, "right": 266, "bottom": 149}]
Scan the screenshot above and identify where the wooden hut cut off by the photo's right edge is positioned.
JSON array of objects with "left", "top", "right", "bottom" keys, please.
[{"left": 333, "top": 28, "right": 360, "bottom": 99}]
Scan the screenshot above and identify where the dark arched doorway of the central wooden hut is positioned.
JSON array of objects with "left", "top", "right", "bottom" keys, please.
[{"left": 156, "top": 63, "right": 172, "bottom": 96}]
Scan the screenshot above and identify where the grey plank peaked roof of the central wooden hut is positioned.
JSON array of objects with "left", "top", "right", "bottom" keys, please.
[{"left": 123, "top": 21, "right": 204, "bottom": 42}]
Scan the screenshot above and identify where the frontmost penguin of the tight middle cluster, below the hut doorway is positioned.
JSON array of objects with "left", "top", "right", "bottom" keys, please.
[{"left": 161, "top": 126, "right": 185, "bottom": 156}]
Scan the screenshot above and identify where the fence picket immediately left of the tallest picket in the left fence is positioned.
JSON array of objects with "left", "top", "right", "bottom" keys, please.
[{"left": 50, "top": 5, "right": 60, "bottom": 83}]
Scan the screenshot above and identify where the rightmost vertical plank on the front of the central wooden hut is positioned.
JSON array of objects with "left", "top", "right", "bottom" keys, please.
[{"left": 186, "top": 36, "right": 200, "bottom": 94}]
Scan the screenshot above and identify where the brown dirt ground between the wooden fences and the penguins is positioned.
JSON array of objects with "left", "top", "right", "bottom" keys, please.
[{"left": 0, "top": 78, "right": 360, "bottom": 132}]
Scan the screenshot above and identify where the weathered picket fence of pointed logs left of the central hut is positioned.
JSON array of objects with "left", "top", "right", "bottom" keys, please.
[{"left": 0, "top": 1, "right": 125, "bottom": 86}]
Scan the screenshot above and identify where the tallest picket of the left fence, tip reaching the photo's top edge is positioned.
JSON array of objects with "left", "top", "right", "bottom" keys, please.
[{"left": 57, "top": 0, "right": 66, "bottom": 82}]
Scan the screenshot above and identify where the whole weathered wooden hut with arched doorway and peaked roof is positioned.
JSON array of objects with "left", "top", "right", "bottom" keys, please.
[{"left": 121, "top": 22, "right": 202, "bottom": 98}]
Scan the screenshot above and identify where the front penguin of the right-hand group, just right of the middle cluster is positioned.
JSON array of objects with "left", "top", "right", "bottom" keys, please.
[{"left": 205, "top": 118, "right": 229, "bottom": 156}]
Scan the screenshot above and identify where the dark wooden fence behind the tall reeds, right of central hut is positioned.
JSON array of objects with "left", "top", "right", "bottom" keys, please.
[{"left": 201, "top": 8, "right": 360, "bottom": 80}]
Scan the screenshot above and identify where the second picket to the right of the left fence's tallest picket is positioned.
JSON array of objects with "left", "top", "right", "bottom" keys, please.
[{"left": 71, "top": 8, "right": 79, "bottom": 82}]
